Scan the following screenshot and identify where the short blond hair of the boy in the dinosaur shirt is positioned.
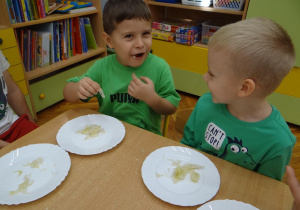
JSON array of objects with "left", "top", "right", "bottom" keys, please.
[{"left": 208, "top": 18, "right": 295, "bottom": 95}]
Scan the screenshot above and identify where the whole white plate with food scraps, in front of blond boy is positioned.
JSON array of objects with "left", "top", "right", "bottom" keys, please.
[{"left": 142, "top": 146, "right": 220, "bottom": 206}]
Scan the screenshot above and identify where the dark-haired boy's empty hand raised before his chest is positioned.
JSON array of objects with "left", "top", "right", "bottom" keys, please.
[{"left": 128, "top": 73, "right": 155, "bottom": 101}]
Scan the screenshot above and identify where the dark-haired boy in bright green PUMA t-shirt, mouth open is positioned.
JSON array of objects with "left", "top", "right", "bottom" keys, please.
[{"left": 64, "top": 0, "right": 180, "bottom": 134}]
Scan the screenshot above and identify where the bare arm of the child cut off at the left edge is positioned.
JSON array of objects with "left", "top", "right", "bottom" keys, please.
[{"left": 3, "top": 70, "right": 34, "bottom": 122}]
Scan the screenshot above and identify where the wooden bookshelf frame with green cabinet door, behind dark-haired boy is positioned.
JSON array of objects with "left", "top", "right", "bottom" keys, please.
[{"left": 0, "top": 0, "right": 107, "bottom": 120}]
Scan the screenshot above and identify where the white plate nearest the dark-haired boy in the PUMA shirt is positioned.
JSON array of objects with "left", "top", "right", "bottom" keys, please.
[{"left": 56, "top": 114, "right": 125, "bottom": 155}]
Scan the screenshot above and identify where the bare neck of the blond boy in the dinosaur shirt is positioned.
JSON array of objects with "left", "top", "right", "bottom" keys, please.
[{"left": 227, "top": 99, "right": 272, "bottom": 122}]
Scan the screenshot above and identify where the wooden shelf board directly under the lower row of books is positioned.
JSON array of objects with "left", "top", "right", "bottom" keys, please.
[{"left": 26, "top": 48, "right": 106, "bottom": 81}]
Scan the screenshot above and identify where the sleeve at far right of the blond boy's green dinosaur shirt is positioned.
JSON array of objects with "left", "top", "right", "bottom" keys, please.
[{"left": 254, "top": 146, "right": 293, "bottom": 181}]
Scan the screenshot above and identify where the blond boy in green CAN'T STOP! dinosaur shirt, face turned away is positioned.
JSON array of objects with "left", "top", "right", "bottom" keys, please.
[{"left": 181, "top": 18, "right": 296, "bottom": 180}]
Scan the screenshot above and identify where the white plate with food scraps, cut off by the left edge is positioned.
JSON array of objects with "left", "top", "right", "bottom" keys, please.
[{"left": 0, "top": 144, "right": 71, "bottom": 205}]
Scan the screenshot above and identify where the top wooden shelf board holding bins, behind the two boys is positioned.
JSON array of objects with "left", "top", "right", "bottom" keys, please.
[{"left": 148, "top": 1, "right": 243, "bottom": 15}]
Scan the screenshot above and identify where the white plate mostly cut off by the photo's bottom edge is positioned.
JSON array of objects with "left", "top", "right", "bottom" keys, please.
[{"left": 198, "top": 200, "right": 259, "bottom": 210}]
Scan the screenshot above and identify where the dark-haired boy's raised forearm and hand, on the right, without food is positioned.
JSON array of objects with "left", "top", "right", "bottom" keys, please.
[{"left": 128, "top": 74, "right": 177, "bottom": 115}]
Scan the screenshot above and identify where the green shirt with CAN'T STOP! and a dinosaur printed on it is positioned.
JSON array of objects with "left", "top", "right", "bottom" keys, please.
[{"left": 181, "top": 93, "right": 296, "bottom": 180}]
